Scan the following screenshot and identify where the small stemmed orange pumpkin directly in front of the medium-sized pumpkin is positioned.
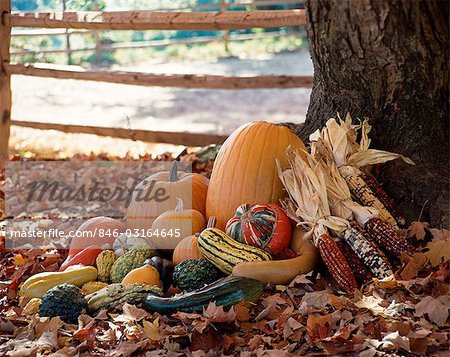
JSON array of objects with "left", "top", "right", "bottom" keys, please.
[{"left": 151, "top": 198, "right": 206, "bottom": 250}]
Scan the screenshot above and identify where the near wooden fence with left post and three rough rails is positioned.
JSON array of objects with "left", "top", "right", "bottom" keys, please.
[{"left": 0, "top": 0, "right": 312, "bottom": 158}]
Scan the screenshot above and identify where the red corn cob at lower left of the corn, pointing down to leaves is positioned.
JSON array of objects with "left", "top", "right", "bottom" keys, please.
[{"left": 317, "top": 234, "right": 358, "bottom": 292}]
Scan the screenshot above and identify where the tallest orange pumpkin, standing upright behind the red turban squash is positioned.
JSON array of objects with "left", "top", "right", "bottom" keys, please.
[{"left": 206, "top": 121, "right": 305, "bottom": 230}]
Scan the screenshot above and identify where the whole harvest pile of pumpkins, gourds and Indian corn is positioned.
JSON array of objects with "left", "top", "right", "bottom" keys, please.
[{"left": 20, "top": 116, "right": 414, "bottom": 323}]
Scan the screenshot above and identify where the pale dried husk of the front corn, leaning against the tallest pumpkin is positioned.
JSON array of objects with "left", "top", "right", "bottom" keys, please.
[{"left": 277, "top": 148, "right": 349, "bottom": 245}]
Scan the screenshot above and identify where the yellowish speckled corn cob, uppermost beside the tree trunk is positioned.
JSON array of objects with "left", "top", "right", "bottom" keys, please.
[{"left": 339, "top": 166, "right": 398, "bottom": 230}]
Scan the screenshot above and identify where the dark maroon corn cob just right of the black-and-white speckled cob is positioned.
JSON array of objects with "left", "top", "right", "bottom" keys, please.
[{"left": 364, "top": 217, "right": 415, "bottom": 257}]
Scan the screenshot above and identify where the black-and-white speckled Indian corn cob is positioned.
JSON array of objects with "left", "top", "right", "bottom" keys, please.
[{"left": 341, "top": 228, "right": 393, "bottom": 279}]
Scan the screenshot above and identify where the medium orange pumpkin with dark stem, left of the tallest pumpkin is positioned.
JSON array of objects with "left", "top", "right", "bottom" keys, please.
[{"left": 127, "top": 161, "right": 209, "bottom": 229}]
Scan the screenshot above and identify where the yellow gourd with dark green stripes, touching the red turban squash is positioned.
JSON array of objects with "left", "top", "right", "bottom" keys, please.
[{"left": 198, "top": 228, "right": 272, "bottom": 274}]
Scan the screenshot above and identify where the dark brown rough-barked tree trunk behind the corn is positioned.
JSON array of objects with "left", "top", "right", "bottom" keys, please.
[{"left": 300, "top": 0, "right": 450, "bottom": 227}]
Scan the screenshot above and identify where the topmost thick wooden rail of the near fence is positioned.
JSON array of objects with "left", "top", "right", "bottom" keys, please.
[{"left": 7, "top": 10, "right": 306, "bottom": 31}]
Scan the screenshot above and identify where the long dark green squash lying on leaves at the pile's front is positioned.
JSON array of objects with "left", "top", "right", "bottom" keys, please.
[{"left": 143, "top": 276, "right": 265, "bottom": 314}]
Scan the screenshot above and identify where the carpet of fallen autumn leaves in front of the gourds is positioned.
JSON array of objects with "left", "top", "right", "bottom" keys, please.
[{"left": 0, "top": 155, "right": 450, "bottom": 356}]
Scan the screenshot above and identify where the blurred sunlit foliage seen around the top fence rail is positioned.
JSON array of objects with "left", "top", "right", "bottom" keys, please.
[{"left": 11, "top": 0, "right": 306, "bottom": 66}]
